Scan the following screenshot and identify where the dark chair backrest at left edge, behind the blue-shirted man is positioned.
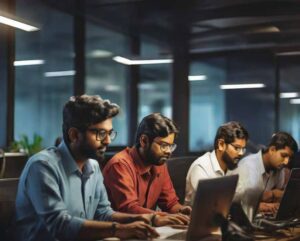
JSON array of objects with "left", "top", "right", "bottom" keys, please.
[{"left": 0, "top": 178, "right": 19, "bottom": 240}]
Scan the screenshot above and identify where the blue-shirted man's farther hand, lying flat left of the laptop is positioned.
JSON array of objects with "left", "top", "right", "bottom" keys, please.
[{"left": 152, "top": 213, "right": 190, "bottom": 227}]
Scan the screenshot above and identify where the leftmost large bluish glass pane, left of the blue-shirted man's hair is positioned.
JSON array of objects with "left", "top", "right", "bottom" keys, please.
[{"left": 14, "top": 1, "right": 74, "bottom": 146}]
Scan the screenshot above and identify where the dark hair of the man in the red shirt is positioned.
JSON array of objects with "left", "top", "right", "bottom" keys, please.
[{"left": 135, "top": 113, "right": 179, "bottom": 147}]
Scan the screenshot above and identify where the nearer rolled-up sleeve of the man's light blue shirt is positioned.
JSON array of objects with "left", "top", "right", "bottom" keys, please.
[{"left": 25, "top": 161, "right": 84, "bottom": 240}]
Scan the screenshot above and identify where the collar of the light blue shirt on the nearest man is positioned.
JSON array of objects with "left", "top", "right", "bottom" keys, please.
[{"left": 58, "top": 141, "right": 94, "bottom": 176}]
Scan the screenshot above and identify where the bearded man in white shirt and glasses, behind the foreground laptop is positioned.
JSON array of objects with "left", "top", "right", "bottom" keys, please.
[{"left": 185, "top": 121, "right": 248, "bottom": 205}]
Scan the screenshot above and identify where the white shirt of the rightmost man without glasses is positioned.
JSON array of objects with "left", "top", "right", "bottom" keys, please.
[{"left": 231, "top": 151, "right": 284, "bottom": 220}]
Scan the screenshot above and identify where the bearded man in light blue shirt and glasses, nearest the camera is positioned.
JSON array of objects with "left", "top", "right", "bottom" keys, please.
[{"left": 15, "top": 95, "right": 157, "bottom": 241}]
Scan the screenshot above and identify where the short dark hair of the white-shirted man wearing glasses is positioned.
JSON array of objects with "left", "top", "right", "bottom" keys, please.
[{"left": 214, "top": 121, "right": 249, "bottom": 149}]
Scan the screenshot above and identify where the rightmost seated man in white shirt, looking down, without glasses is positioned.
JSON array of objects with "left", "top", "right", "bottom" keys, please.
[{"left": 235, "top": 132, "right": 298, "bottom": 214}]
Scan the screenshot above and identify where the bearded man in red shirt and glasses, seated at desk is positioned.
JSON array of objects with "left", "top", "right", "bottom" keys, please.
[{"left": 103, "top": 113, "right": 191, "bottom": 218}]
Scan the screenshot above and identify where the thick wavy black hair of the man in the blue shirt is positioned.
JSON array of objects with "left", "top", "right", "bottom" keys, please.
[{"left": 62, "top": 95, "right": 120, "bottom": 144}]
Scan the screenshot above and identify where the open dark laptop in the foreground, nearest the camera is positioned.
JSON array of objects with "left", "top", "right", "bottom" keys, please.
[{"left": 157, "top": 175, "right": 238, "bottom": 241}]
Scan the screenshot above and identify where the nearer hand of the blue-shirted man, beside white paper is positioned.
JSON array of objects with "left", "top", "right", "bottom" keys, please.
[{"left": 115, "top": 221, "right": 159, "bottom": 240}]
